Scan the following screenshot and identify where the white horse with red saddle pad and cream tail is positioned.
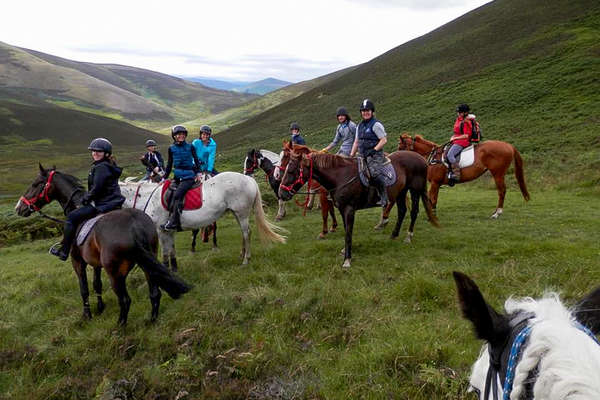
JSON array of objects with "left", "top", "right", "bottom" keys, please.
[{"left": 119, "top": 172, "right": 285, "bottom": 269}]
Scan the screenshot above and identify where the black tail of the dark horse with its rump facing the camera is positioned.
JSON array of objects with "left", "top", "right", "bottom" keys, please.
[{"left": 132, "top": 215, "right": 192, "bottom": 299}]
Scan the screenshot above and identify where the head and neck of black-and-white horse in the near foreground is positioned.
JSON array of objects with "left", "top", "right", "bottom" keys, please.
[{"left": 453, "top": 271, "right": 600, "bottom": 400}]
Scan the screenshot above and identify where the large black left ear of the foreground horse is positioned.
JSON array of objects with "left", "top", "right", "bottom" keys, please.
[{"left": 452, "top": 271, "right": 509, "bottom": 344}]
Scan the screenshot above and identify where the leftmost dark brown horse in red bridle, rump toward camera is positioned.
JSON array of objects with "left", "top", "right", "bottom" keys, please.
[{"left": 15, "top": 164, "right": 191, "bottom": 326}]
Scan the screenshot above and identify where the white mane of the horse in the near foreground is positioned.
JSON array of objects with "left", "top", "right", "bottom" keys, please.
[{"left": 474, "top": 293, "right": 600, "bottom": 400}]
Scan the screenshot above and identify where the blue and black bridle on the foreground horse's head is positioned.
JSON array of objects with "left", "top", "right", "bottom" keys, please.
[{"left": 482, "top": 312, "right": 600, "bottom": 400}]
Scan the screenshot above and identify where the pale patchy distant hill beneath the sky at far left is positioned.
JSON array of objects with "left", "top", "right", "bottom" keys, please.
[{"left": 0, "top": 42, "right": 256, "bottom": 128}]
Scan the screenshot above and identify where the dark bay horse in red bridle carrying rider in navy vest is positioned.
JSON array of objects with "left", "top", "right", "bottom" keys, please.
[{"left": 279, "top": 145, "right": 439, "bottom": 268}]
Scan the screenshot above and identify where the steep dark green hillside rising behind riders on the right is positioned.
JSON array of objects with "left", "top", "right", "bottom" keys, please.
[{"left": 218, "top": 0, "right": 600, "bottom": 186}]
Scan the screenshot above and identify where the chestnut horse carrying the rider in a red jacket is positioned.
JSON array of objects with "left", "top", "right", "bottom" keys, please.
[{"left": 398, "top": 133, "right": 529, "bottom": 219}]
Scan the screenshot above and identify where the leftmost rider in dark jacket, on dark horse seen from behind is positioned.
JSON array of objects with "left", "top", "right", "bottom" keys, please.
[{"left": 50, "top": 138, "right": 125, "bottom": 261}]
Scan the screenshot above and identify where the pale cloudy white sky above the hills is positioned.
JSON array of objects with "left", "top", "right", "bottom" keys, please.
[{"left": 0, "top": 0, "right": 489, "bottom": 82}]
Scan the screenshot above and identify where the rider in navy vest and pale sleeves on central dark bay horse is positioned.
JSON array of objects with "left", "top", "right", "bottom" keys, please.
[{"left": 350, "top": 99, "right": 388, "bottom": 207}]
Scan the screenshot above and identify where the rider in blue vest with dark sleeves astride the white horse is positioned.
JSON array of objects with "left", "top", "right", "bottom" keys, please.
[{"left": 161, "top": 125, "right": 201, "bottom": 231}]
